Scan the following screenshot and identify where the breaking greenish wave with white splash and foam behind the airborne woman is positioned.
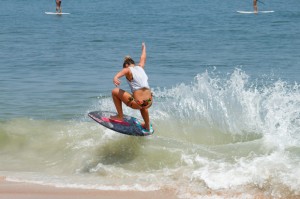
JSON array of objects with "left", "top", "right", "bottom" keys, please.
[{"left": 0, "top": 69, "right": 300, "bottom": 198}]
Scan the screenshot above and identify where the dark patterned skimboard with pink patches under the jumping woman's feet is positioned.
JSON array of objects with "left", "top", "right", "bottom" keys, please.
[{"left": 88, "top": 111, "right": 154, "bottom": 136}]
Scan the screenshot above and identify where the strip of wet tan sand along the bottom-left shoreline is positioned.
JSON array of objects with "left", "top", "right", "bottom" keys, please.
[{"left": 0, "top": 177, "right": 177, "bottom": 199}]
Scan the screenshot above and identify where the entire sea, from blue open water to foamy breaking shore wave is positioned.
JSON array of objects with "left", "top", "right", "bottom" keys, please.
[{"left": 0, "top": 0, "right": 300, "bottom": 198}]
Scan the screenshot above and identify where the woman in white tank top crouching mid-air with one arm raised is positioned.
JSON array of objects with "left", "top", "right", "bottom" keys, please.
[{"left": 111, "top": 43, "right": 152, "bottom": 131}]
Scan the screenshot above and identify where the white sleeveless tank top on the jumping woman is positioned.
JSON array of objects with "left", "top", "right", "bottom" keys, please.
[{"left": 127, "top": 66, "right": 150, "bottom": 93}]
